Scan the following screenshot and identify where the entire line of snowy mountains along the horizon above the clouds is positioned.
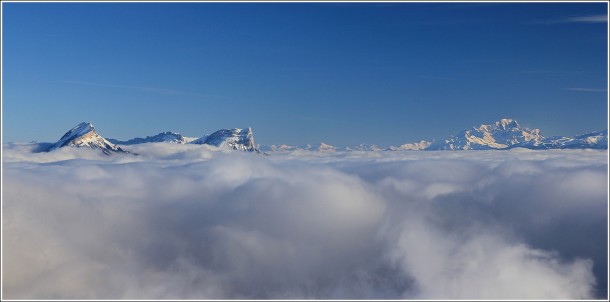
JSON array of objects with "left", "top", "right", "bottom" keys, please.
[{"left": 40, "top": 119, "right": 608, "bottom": 154}]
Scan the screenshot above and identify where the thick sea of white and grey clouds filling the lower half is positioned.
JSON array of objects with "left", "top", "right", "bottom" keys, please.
[{"left": 2, "top": 143, "right": 608, "bottom": 299}]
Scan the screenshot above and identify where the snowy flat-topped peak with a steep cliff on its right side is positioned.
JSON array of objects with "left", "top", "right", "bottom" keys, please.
[{"left": 191, "top": 127, "right": 258, "bottom": 151}]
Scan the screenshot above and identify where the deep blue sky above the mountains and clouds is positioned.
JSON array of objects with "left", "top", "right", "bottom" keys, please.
[{"left": 2, "top": 2, "right": 608, "bottom": 146}]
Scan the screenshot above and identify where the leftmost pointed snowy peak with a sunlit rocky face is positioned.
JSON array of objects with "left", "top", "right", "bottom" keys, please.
[{"left": 48, "top": 122, "right": 127, "bottom": 154}]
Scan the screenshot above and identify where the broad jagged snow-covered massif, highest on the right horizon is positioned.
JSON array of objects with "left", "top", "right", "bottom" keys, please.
[{"left": 426, "top": 119, "right": 544, "bottom": 150}]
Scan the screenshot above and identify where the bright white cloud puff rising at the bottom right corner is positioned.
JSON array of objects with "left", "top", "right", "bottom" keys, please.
[{"left": 394, "top": 217, "right": 595, "bottom": 299}]
